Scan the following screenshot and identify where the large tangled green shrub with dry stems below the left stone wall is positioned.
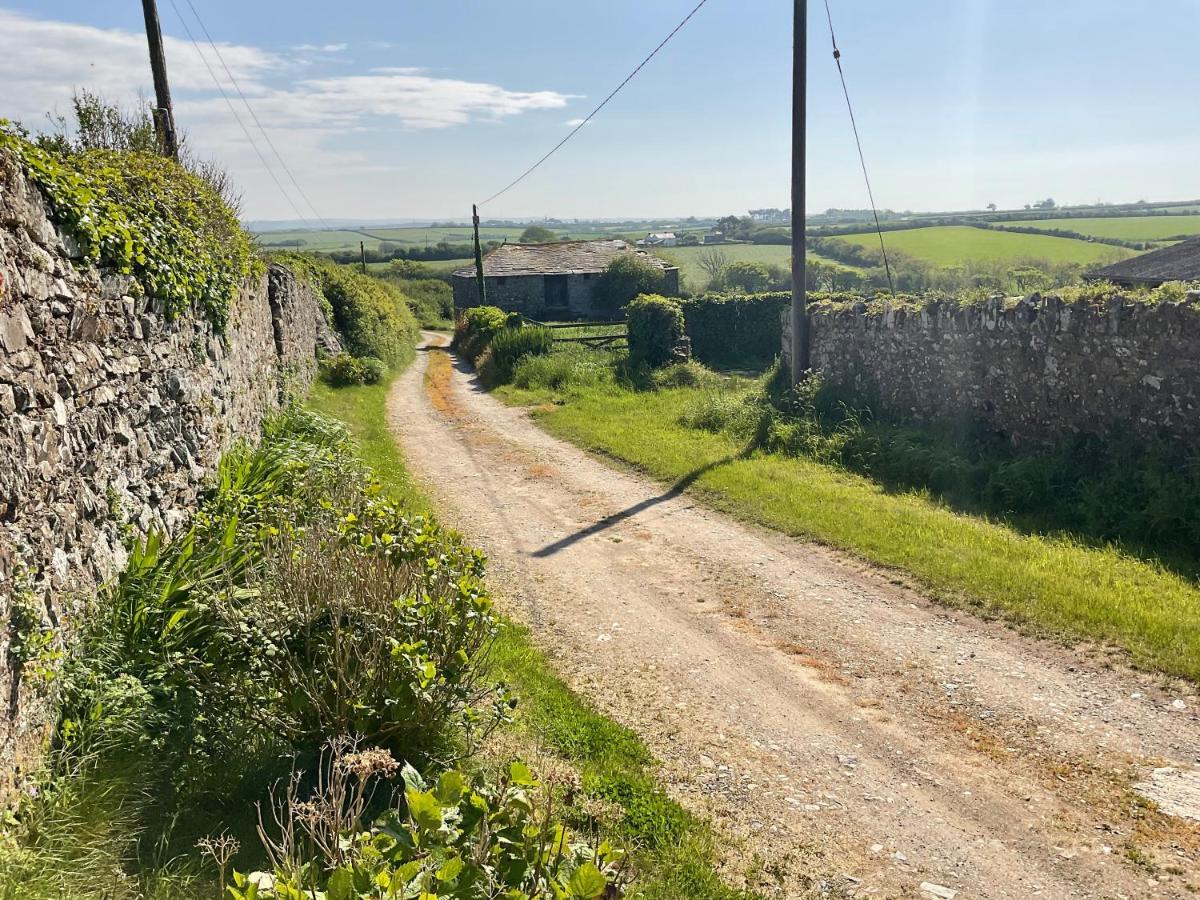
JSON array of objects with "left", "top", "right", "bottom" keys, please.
[{"left": 60, "top": 413, "right": 508, "bottom": 796}]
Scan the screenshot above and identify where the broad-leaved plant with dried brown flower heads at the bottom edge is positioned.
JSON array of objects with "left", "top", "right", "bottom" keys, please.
[{"left": 240, "top": 739, "right": 625, "bottom": 900}]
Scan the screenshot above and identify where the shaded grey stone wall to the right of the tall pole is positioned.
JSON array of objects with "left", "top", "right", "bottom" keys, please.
[{"left": 784, "top": 293, "right": 1200, "bottom": 444}]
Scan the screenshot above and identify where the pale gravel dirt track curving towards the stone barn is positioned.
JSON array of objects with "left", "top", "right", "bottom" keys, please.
[{"left": 389, "top": 335, "right": 1200, "bottom": 899}]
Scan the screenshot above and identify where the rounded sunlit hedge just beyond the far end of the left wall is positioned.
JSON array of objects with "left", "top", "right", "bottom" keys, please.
[{"left": 316, "top": 264, "right": 419, "bottom": 367}]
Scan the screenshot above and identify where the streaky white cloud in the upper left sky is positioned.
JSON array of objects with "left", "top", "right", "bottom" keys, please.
[{"left": 0, "top": 10, "right": 569, "bottom": 215}]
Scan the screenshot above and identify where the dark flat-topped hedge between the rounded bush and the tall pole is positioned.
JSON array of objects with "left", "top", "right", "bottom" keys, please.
[{"left": 680, "top": 293, "right": 791, "bottom": 366}]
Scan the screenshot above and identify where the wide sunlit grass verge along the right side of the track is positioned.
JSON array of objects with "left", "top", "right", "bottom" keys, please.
[{"left": 499, "top": 385, "right": 1200, "bottom": 680}]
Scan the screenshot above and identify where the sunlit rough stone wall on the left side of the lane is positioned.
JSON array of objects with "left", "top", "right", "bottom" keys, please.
[{"left": 0, "top": 158, "right": 324, "bottom": 797}]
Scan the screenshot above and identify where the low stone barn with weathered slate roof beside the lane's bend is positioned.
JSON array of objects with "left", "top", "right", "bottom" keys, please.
[{"left": 451, "top": 240, "right": 679, "bottom": 319}]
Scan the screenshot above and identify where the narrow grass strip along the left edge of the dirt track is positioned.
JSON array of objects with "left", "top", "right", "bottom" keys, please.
[{"left": 310, "top": 369, "right": 754, "bottom": 900}]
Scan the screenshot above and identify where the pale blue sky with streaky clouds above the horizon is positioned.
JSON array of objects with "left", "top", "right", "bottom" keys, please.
[{"left": 0, "top": 0, "right": 1200, "bottom": 218}]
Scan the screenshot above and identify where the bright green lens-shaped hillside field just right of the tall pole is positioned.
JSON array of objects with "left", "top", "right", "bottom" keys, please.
[{"left": 830, "top": 226, "right": 1136, "bottom": 265}]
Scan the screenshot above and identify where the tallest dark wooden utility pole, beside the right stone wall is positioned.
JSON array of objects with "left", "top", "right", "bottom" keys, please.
[{"left": 792, "top": 0, "right": 809, "bottom": 384}]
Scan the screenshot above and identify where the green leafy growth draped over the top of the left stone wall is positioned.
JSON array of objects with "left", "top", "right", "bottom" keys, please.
[{"left": 0, "top": 120, "right": 259, "bottom": 329}]
